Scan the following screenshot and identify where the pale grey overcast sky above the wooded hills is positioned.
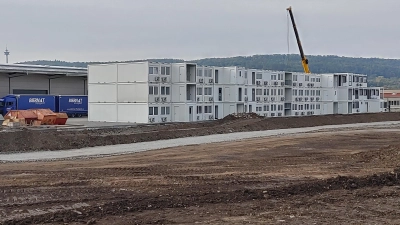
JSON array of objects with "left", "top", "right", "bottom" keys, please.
[{"left": 0, "top": 0, "right": 400, "bottom": 63}]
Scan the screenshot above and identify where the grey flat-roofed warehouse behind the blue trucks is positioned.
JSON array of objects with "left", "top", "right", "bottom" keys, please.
[{"left": 0, "top": 64, "right": 87, "bottom": 97}]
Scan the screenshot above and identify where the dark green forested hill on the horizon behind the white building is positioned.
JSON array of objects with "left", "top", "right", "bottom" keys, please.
[{"left": 21, "top": 54, "right": 400, "bottom": 89}]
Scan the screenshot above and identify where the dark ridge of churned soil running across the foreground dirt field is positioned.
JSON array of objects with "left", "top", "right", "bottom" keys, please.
[{"left": 0, "top": 169, "right": 400, "bottom": 225}]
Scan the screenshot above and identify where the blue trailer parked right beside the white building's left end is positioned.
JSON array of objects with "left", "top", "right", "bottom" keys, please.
[{"left": 56, "top": 95, "right": 88, "bottom": 115}]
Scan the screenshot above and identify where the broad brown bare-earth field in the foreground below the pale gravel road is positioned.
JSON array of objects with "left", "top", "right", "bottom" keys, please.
[{"left": 0, "top": 128, "right": 400, "bottom": 225}]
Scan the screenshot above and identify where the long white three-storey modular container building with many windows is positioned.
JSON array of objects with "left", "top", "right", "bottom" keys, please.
[{"left": 88, "top": 61, "right": 384, "bottom": 123}]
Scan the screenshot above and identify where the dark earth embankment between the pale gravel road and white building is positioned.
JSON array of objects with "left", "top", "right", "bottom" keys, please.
[{"left": 0, "top": 112, "right": 400, "bottom": 153}]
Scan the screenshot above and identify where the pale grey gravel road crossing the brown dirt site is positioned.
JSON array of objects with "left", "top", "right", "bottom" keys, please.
[{"left": 0, "top": 121, "right": 400, "bottom": 162}]
